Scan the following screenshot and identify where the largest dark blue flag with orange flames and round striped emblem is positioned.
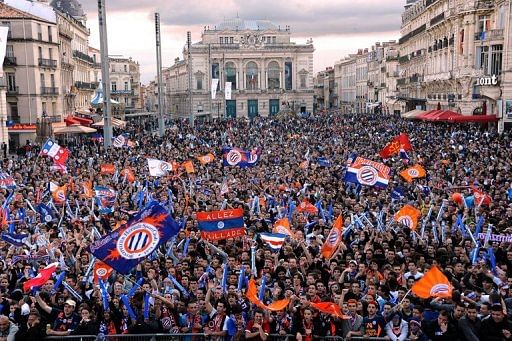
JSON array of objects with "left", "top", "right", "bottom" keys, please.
[{"left": 89, "top": 202, "right": 180, "bottom": 274}]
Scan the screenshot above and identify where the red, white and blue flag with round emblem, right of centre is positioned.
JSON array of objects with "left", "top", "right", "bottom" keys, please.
[{"left": 344, "top": 156, "right": 390, "bottom": 188}]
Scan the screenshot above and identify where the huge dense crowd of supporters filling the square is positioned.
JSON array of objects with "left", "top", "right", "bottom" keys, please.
[{"left": 0, "top": 111, "right": 512, "bottom": 341}]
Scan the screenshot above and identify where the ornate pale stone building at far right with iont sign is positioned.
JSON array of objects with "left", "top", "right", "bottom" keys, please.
[{"left": 397, "top": 0, "right": 512, "bottom": 129}]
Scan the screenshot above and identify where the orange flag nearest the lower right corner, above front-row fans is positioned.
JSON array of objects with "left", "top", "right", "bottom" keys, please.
[{"left": 411, "top": 265, "right": 453, "bottom": 299}]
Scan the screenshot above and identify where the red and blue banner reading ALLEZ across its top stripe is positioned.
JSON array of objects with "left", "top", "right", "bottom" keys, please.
[{"left": 196, "top": 208, "right": 245, "bottom": 240}]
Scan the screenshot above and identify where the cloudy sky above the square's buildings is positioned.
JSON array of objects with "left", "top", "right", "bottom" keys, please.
[{"left": 81, "top": 0, "right": 405, "bottom": 83}]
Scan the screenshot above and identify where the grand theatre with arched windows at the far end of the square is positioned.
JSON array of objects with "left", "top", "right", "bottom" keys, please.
[{"left": 163, "top": 18, "right": 314, "bottom": 118}]
